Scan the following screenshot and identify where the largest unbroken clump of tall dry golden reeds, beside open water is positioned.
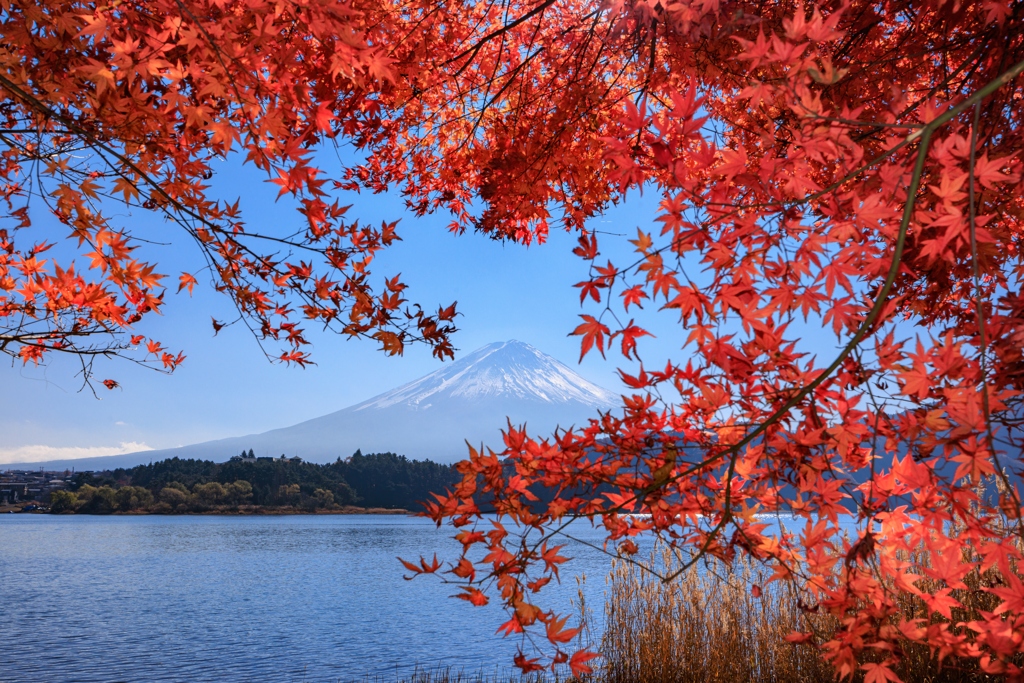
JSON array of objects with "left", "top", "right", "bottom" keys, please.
[{"left": 600, "top": 552, "right": 834, "bottom": 683}]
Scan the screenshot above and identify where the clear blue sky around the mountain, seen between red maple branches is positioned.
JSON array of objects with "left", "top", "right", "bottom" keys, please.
[{"left": 0, "top": 157, "right": 681, "bottom": 463}]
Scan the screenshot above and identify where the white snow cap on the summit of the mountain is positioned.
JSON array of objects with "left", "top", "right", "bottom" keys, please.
[{"left": 351, "top": 340, "right": 615, "bottom": 411}]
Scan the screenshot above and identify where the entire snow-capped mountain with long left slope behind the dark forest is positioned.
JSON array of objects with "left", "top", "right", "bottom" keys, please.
[{"left": 22, "top": 341, "right": 617, "bottom": 469}]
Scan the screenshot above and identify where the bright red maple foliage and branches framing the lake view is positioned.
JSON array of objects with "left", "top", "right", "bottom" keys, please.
[{"left": 6, "top": 0, "right": 1024, "bottom": 682}]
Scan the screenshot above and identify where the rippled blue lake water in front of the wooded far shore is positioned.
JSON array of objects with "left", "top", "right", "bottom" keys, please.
[{"left": 0, "top": 514, "right": 610, "bottom": 683}]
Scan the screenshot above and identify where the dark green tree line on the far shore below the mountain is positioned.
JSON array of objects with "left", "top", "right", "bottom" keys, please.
[{"left": 29, "top": 451, "right": 459, "bottom": 514}]
